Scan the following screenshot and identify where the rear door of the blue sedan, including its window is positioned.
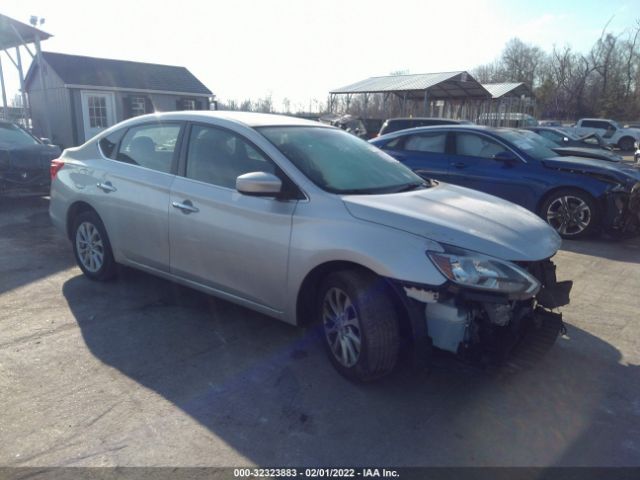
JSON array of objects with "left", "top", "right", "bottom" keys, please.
[{"left": 382, "top": 130, "right": 449, "bottom": 181}]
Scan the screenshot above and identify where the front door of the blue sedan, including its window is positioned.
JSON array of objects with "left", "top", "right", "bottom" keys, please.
[{"left": 449, "top": 132, "right": 537, "bottom": 209}]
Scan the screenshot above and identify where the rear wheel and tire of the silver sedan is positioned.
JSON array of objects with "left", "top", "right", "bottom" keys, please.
[{"left": 71, "top": 211, "right": 116, "bottom": 281}]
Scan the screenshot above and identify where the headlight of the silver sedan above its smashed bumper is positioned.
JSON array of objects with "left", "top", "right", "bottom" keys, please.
[{"left": 427, "top": 249, "right": 540, "bottom": 300}]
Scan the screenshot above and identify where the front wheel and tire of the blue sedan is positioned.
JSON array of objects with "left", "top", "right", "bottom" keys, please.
[{"left": 540, "top": 188, "right": 600, "bottom": 239}]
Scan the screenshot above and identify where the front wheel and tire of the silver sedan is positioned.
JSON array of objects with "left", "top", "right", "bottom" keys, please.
[{"left": 315, "top": 270, "right": 400, "bottom": 382}]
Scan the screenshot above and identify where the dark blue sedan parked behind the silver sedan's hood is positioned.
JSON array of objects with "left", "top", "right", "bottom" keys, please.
[{"left": 371, "top": 125, "right": 640, "bottom": 238}]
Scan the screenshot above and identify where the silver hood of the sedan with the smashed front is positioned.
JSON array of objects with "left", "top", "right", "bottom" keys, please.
[{"left": 343, "top": 183, "right": 561, "bottom": 261}]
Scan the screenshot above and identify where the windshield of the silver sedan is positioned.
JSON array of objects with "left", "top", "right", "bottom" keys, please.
[{"left": 258, "top": 127, "right": 426, "bottom": 194}]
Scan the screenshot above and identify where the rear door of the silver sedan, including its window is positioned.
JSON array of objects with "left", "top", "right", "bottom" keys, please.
[{"left": 97, "top": 122, "right": 184, "bottom": 272}]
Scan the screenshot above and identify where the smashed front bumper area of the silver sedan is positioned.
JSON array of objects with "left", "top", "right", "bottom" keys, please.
[{"left": 396, "top": 260, "right": 572, "bottom": 364}]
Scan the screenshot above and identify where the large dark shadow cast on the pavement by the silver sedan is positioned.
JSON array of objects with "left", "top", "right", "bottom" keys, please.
[{"left": 63, "top": 269, "right": 640, "bottom": 466}]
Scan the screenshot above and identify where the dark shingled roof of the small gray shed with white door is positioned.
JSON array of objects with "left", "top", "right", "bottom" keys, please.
[{"left": 26, "top": 52, "right": 211, "bottom": 95}]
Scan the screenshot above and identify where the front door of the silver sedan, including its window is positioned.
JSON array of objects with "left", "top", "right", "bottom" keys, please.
[{"left": 169, "top": 124, "right": 297, "bottom": 312}]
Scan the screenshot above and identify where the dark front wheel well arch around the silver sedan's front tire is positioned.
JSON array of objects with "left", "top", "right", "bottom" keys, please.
[{"left": 296, "top": 261, "right": 412, "bottom": 338}]
